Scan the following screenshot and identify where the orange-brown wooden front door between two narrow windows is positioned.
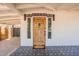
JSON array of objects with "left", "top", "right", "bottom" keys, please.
[{"left": 33, "top": 17, "right": 46, "bottom": 48}]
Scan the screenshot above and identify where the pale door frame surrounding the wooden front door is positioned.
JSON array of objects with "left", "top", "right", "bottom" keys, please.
[{"left": 31, "top": 16, "right": 48, "bottom": 48}]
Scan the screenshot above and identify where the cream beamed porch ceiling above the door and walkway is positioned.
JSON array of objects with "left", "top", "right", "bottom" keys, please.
[{"left": 0, "top": 3, "right": 79, "bottom": 24}]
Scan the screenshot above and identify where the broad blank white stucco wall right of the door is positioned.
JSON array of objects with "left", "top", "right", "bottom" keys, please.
[{"left": 48, "top": 11, "right": 79, "bottom": 45}]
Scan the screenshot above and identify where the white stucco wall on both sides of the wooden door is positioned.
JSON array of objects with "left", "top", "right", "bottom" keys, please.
[{"left": 21, "top": 11, "right": 79, "bottom": 46}]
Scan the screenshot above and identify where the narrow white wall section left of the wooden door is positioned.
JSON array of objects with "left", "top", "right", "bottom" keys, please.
[{"left": 20, "top": 19, "right": 33, "bottom": 46}]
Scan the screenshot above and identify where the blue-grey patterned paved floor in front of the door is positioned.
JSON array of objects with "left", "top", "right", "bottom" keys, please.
[{"left": 10, "top": 46, "right": 79, "bottom": 56}]
